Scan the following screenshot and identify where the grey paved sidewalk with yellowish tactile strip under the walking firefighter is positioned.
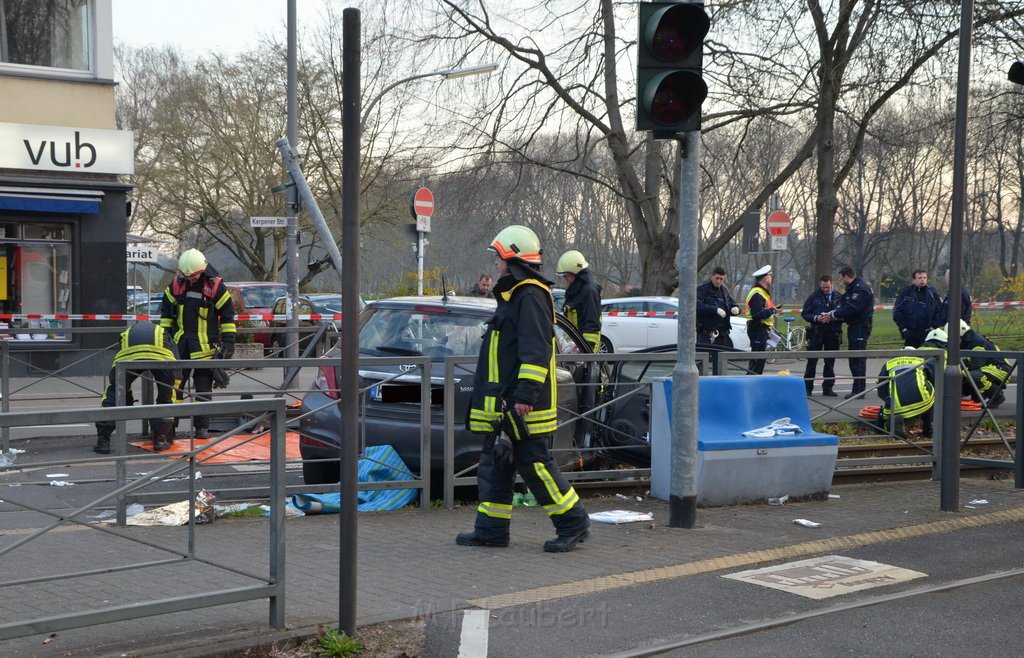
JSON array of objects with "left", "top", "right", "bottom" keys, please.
[{"left": 0, "top": 478, "right": 1024, "bottom": 656}]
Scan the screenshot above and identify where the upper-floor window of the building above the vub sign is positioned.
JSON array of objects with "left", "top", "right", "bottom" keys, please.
[{"left": 0, "top": 0, "right": 91, "bottom": 71}]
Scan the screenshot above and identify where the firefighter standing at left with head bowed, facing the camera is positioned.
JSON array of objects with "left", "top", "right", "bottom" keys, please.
[{"left": 160, "top": 249, "right": 237, "bottom": 439}]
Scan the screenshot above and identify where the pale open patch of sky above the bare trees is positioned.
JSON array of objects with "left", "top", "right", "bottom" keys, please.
[{"left": 113, "top": 0, "right": 335, "bottom": 56}]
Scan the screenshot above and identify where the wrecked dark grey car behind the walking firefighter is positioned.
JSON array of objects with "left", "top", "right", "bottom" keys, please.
[{"left": 299, "top": 297, "right": 600, "bottom": 484}]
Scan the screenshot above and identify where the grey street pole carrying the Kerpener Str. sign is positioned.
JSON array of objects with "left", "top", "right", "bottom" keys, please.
[{"left": 285, "top": 0, "right": 299, "bottom": 362}]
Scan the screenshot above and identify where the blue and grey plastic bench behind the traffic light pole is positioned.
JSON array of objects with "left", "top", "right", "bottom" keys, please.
[{"left": 650, "top": 376, "right": 839, "bottom": 506}]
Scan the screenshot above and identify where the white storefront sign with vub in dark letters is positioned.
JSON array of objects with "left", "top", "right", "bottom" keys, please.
[{"left": 0, "top": 123, "right": 135, "bottom": 174}]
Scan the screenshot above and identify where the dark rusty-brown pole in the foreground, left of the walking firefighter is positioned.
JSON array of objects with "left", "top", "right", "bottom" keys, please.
[{"left": 338, "top": 7, "right": 361, "bottom": 635}]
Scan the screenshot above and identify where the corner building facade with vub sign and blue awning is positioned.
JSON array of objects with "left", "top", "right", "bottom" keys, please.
[{"left": 0, "top": 0, "right": 134, "bottom": 377}]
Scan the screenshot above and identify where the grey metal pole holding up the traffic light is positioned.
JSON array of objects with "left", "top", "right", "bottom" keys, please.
[{"left": 669, "top": 131, "right": 700, "bottom": 528}]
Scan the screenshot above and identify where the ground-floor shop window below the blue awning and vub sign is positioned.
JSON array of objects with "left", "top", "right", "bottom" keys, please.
[{"left": 0, "top": 222, "right": 72, "bottom": 341}]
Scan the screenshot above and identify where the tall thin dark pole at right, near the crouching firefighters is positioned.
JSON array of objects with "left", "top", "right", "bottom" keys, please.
[{"left": 939, "top": 0, "right": 974, "bottom": 512}]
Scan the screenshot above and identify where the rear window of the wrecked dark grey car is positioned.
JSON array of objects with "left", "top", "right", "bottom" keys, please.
[{"left": 359, "top": 306, "right": 488, "bottom": 356}]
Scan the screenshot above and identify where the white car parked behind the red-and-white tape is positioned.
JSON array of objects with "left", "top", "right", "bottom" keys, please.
[{"left": 601, "top": 297, "right": 751, "bottom": 352}]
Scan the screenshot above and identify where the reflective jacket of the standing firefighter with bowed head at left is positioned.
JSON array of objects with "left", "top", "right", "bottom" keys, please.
[{"left": 160, "top": 265, "right": 237, "bottom": 359}]
